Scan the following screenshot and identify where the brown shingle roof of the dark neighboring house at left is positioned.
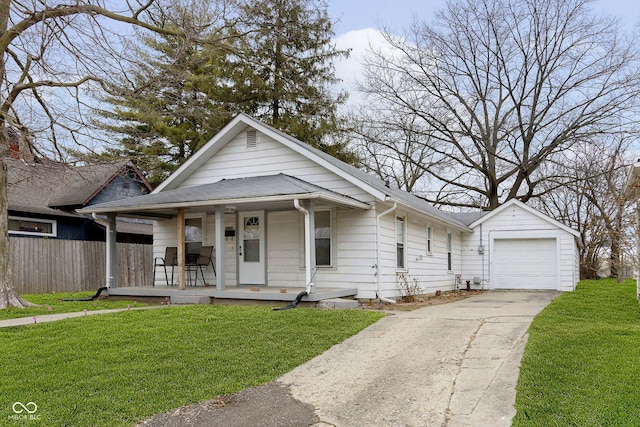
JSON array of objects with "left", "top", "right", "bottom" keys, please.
[{"left": 5, "top": 158, "right": 151, "bottom": 216}]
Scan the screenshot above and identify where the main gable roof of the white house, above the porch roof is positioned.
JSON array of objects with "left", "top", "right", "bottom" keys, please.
[{"left": 153, "top": 113, "right": 470, "bottom": 231}]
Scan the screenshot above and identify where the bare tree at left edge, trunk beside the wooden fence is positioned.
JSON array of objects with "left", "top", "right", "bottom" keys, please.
[{"left": 0, "top": 0, "right": 190, "bottom": 308}]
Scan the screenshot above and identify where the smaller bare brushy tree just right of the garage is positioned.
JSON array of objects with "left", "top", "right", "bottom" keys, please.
[{"left": 536, "top": 138, "right": 634, "bottom": 279}]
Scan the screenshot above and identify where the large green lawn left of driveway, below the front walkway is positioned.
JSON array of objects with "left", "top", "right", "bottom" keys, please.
[{"left": 0, "top": 306, "right": 382, "bottom": 426}]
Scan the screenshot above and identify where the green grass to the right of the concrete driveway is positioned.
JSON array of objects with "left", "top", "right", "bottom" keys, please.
[{"left": 513, "top": 280, "right": 640, "bottom": 426}]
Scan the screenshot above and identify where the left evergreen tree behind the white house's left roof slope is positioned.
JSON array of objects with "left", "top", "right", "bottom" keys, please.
[{"left": 96, "top": 0, "right": 233, "bottom": 185}]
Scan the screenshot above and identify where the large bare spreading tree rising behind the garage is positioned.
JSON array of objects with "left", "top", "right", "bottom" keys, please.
[{"left": 361, "top": 0, "right": 640, "bottom": 209}]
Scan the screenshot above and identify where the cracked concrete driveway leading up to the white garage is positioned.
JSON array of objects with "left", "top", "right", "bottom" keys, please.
[{"left": 141, "top": 291, "right": 559, "bottom": 427}]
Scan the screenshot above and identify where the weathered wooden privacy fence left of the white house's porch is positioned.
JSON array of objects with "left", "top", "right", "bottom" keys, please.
[{"left": 9, "top": 237, "right": 153, "bottom": 294}]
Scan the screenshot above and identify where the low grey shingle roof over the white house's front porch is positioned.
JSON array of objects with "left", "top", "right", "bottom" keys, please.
[{"left": 80, "top": 174, "right": 366, "bottom": 210}]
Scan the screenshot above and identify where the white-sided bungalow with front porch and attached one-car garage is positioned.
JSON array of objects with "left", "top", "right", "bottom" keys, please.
[{"left": 83, "top": 114, "right": 579, "bottom": 301}]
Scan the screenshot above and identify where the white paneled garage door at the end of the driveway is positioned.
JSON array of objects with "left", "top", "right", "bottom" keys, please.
[{"left": 491, "top": 239, "right": 558, "bottom": 289}]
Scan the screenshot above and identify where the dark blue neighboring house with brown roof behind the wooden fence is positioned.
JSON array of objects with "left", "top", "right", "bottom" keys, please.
[{"left": 6, "top": 156, "right": 152, "bottom": 244}]
